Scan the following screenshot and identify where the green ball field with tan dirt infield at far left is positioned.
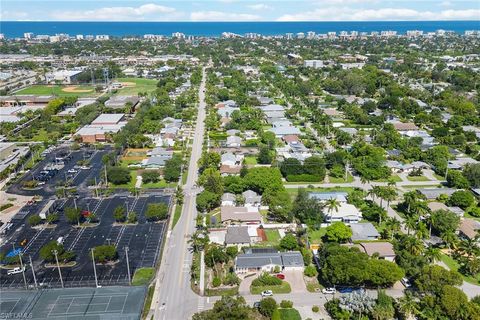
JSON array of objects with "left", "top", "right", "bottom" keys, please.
[{"left": 15, "top": 85, "right": 98, "bottom": 97}]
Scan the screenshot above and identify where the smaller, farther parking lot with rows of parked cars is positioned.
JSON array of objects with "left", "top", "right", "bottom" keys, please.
[{"left": 7, "top": 147, "right": 112, "bottom": 198}]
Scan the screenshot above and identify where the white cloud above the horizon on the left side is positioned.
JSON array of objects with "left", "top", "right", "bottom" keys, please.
[{"left": 51, "top": 3, "right": 178, "bottom": 21}]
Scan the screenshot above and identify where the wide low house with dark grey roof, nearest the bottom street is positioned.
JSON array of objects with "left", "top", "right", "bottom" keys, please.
[{"left": 235, "top": 251, "right": 304, "bottom": 274}]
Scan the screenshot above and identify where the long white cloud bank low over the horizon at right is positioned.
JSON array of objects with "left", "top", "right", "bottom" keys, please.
[{"left": 277, "top": 7, "right": 480, "bottom": 21}]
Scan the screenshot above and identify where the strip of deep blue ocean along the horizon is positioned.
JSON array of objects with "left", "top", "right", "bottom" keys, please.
[{"left": 0, "top": 20, "right": 480, "bottom": 38}]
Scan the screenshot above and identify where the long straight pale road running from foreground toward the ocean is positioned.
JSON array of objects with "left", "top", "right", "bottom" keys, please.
[{"left": 151, "top": 68, "right": 206, "bottom": 320}]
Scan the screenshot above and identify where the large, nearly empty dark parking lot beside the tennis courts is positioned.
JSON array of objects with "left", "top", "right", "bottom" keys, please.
[{"left": 0, "top": 194, "right": 170, "bottom": 288}]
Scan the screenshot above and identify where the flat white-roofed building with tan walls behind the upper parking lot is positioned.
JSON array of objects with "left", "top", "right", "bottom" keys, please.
[{"left": 75, "top": 113, "right": 127, "bottom": 143}]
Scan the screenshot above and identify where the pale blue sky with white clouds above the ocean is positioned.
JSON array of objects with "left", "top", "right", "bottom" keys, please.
[{"left": 0, "top": 0, "right": 480, "bottom": 21}]
